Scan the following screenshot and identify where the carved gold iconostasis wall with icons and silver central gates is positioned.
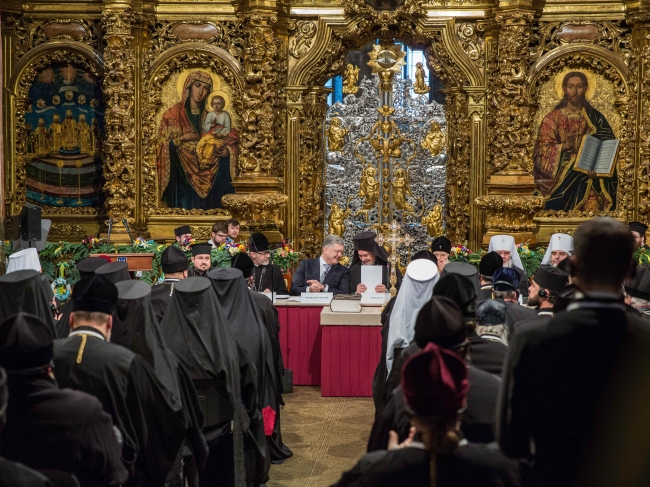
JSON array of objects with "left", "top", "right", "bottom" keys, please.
[{"left": 0, "top": 0, "right": 650, "bottom": 256}]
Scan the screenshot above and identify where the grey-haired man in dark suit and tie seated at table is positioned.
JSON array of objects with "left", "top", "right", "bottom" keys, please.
[{"left": 291, "top": 235, "right": 350, "bottom": 295}]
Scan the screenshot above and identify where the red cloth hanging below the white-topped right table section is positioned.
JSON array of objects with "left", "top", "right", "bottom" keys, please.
[{"left": 321, "top": 326, "right": 381, "bottom": 397}]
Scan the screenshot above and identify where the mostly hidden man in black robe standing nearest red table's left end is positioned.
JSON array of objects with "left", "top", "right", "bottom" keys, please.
[{"left": 231, "top": 253, "right": 293, "bottom": 464}]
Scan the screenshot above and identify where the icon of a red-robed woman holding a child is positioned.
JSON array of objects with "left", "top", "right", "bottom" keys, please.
[{"left": 156, "top": 69, "right": 239, "bottom": 210}]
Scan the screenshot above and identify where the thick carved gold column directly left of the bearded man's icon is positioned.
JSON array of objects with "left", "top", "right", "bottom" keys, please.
[{"left": 475, "top": 0, "right": 544, "bottom": 244}]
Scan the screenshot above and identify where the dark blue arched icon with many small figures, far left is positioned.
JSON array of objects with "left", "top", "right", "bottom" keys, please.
[{"left": 25, "top": 64, "right": 104, "bottom": 207}]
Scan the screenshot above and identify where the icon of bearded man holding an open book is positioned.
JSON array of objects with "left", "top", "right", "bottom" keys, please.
[{"left": 533, "top": 68, "right": 621, "bottom": 212}]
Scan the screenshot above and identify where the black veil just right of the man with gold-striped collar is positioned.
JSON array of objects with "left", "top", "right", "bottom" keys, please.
[{"left": 111, "top": 281, "right": 182, "bottom": 411}]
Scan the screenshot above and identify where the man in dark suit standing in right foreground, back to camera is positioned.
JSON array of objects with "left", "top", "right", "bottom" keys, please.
[{"left": 497, "top": 218, "right": 650, "bottom": 487}]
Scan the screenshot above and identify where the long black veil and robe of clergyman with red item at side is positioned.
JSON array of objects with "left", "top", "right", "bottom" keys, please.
[{"left": 208, "top": 267, "right": 277, "bottom": 482}]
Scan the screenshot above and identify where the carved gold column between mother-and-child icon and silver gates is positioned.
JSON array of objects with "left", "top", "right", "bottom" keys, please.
[{"left": 222, "top": 9, "right": 289, "bottom": 241}]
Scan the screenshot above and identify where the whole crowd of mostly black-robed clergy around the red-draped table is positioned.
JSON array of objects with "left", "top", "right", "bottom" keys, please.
[{"left": 0, "top": 218, "right": 650, "bottom": 487}]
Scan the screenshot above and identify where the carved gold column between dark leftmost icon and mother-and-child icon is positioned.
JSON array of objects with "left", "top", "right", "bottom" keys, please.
[{"left": 102, "top": 0, "right": 136, "bottom": 241}]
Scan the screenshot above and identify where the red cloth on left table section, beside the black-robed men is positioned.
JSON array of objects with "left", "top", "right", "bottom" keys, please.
[{"left": 277, "top": 306, "right": 323, "bottom": 386}]
